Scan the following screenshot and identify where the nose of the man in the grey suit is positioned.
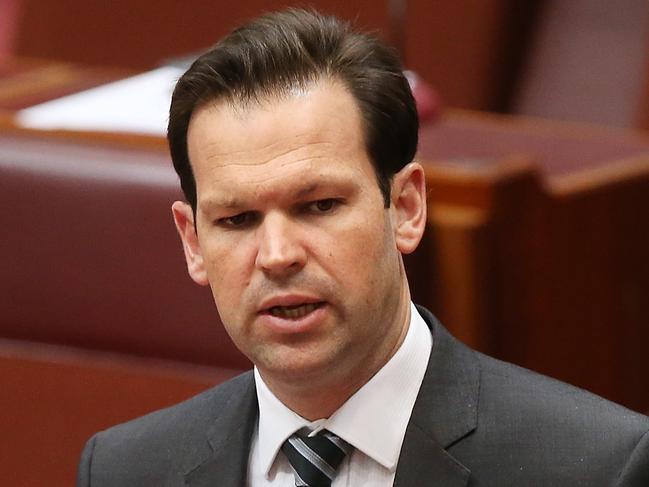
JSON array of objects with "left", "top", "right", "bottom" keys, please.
[{"left": 255, "top": 214, "right": 307, "bottom": 277}]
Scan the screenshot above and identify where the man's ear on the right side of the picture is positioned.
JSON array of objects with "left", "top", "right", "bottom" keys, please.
[{"left": 391, "top": 162, "right": 426, "bottom": 254}]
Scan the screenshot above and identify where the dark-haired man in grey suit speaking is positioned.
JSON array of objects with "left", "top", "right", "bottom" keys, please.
[{"left": 78, "top": 10, "right": 649, "bottom": 487}]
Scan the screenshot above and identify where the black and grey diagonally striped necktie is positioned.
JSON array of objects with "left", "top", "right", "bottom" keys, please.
[{"left": 282, "top": 430, "right": 353, "bottom": 487}]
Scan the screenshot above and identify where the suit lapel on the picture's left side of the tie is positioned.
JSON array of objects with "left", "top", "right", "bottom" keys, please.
[{"left": 185, "top": 374, "right": 258, "bottom": 487}]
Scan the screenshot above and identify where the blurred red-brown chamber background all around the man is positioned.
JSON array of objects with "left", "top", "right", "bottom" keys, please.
[{"left": 0, "top": 0, "right": 649, "bottom": 486}]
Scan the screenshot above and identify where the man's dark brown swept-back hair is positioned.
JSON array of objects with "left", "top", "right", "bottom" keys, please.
[{"left": 167, "top": 9, "right": 419, "bottom": 212}]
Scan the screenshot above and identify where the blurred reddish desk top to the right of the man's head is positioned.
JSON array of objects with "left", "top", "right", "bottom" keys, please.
[{"left": 419, "top": 109, "right": 649, "bottom": 177}]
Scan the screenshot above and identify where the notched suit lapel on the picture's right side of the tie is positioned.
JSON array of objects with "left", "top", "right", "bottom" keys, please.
[{"left": 394, "top": 308, "right": 480, "bottom": 487}]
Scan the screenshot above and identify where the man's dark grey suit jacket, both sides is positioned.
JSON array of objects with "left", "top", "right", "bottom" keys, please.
[{"left": 77, "top": 309, "right": 649, "bottom": 487}]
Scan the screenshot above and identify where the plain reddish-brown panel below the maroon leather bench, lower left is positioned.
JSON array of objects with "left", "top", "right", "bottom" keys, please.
[{"left": 0, "top": 340, "right": 235, "bottom": 487}]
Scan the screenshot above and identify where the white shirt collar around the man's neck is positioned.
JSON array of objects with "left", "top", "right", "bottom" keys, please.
[{"left": 254, "top": 304, "right": 432, "bottom": 476}]
